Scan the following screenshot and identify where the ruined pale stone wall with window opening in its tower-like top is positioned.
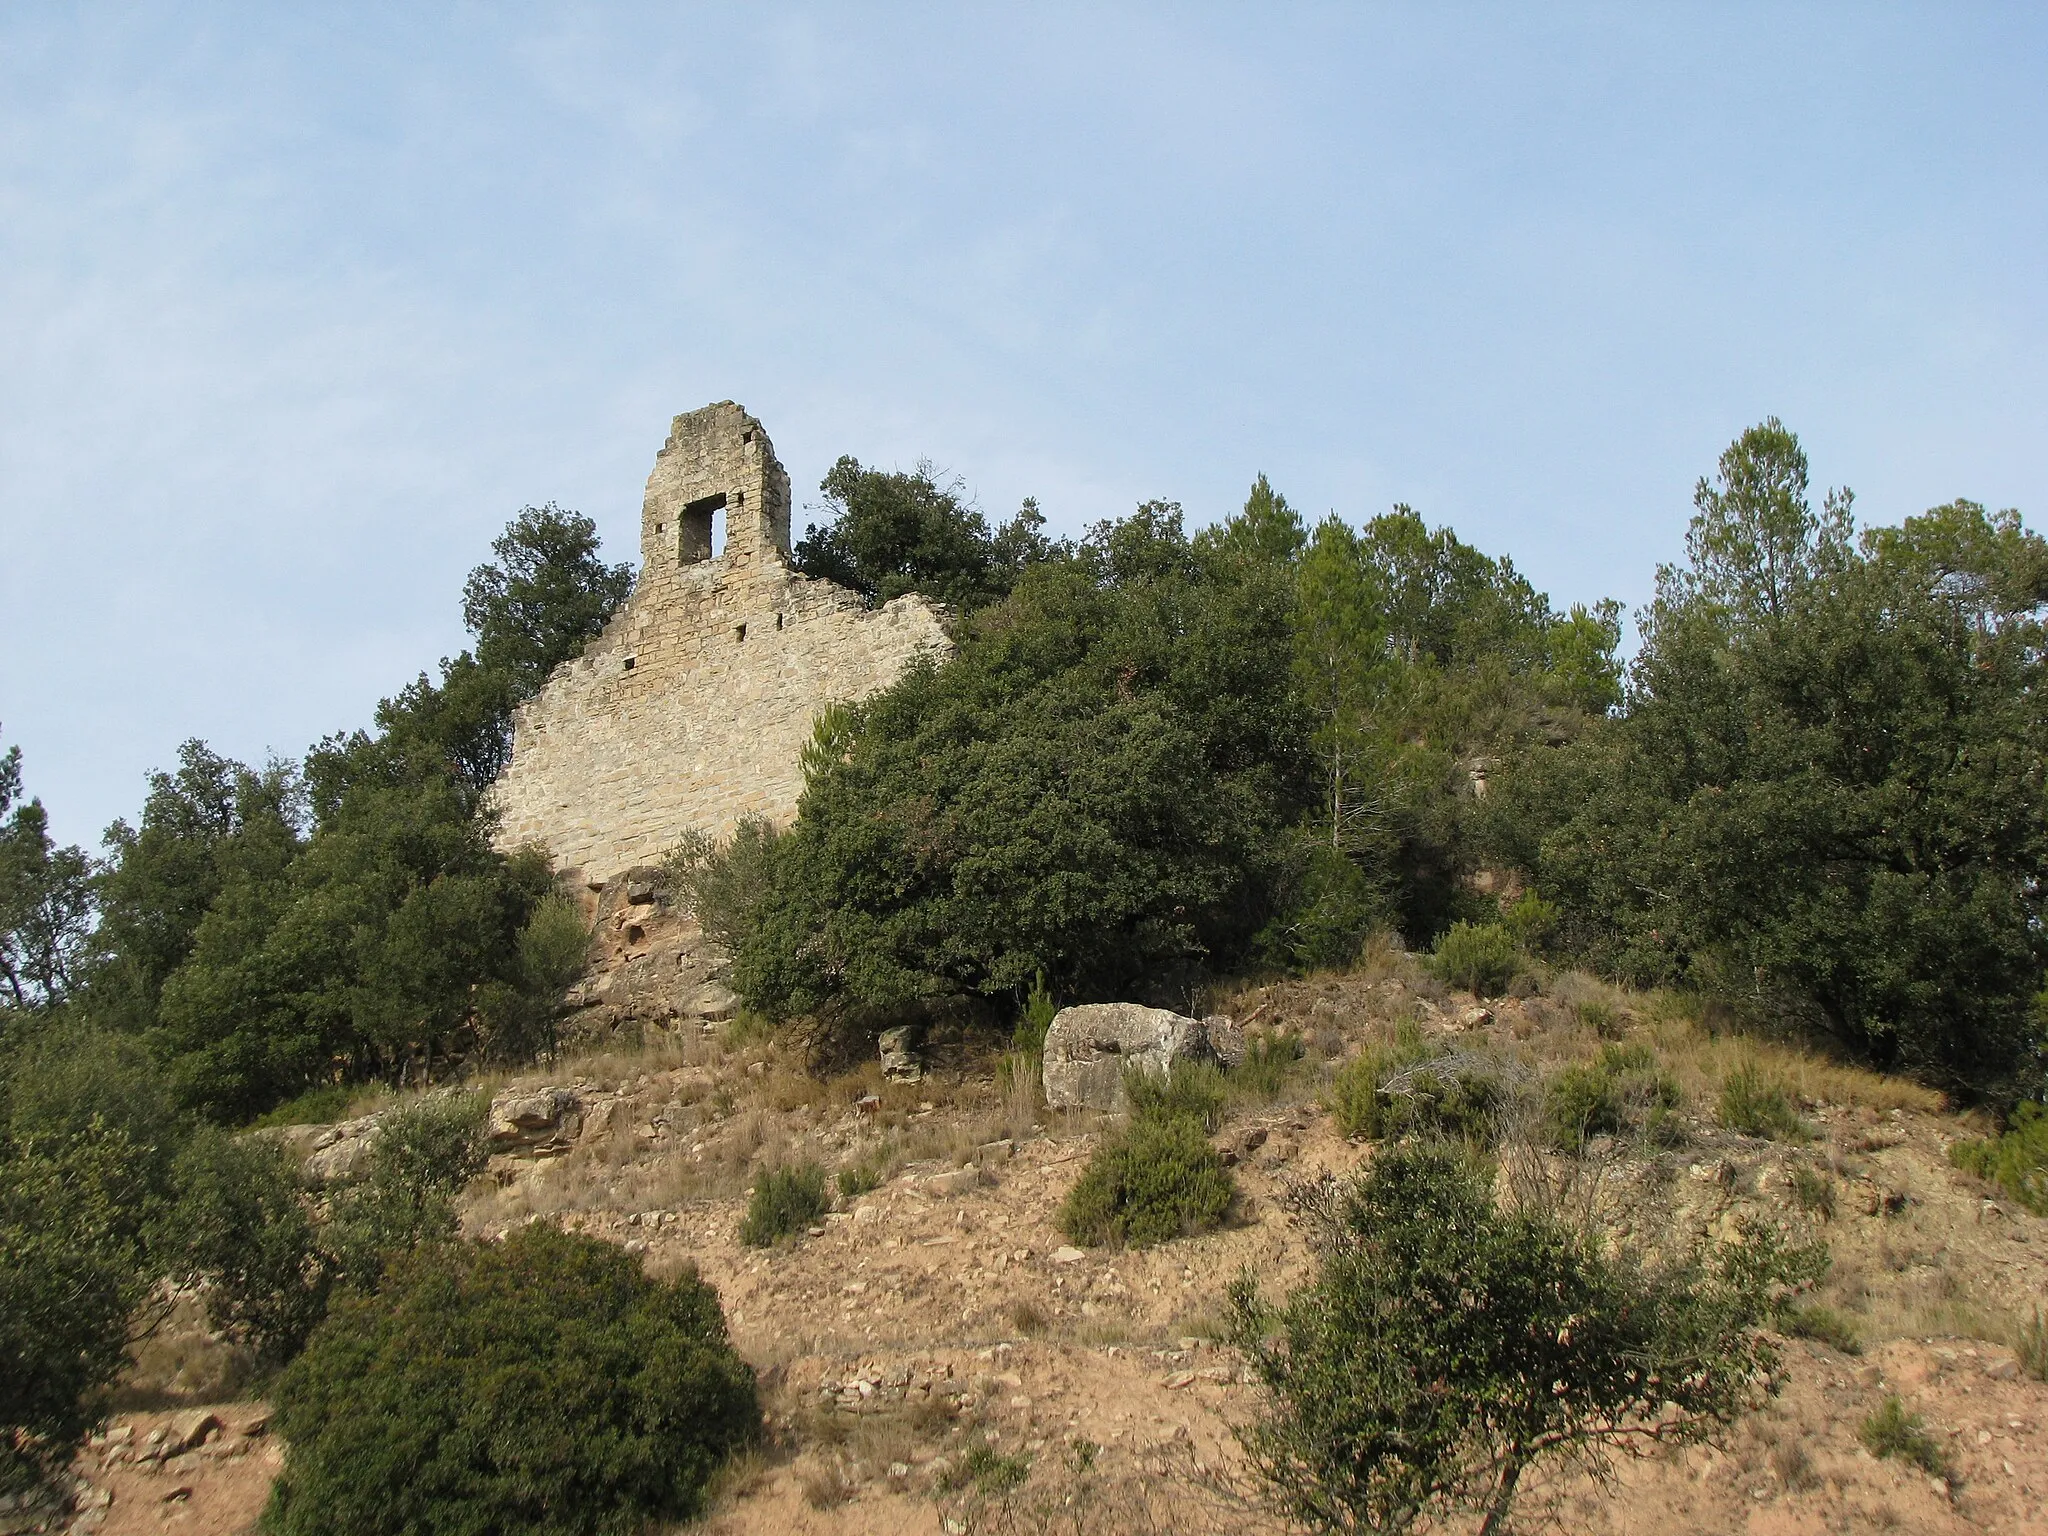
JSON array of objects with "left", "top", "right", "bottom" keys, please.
[{"left": 494, "top": 401, "right": 950, "bottom": 885}]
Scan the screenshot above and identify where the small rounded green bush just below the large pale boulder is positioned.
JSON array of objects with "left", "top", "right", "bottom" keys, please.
[{"left": 1059, "top": 1114, "right": 1235, "bottom": 1247}]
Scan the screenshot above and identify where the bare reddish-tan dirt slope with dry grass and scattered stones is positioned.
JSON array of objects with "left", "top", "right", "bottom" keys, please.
[{"left": 59, "top": 961, "right": 2048, "bottom": 1536}]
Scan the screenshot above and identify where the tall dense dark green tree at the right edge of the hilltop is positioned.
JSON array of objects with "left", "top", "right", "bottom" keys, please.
[{"left": 1499, "top": 422, "right": 2048, "bottom": 1100}]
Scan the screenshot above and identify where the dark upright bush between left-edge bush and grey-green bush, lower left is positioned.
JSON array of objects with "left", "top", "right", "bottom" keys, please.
[{"left": 158, "top": 1126, "right": 334, "bottom": 1362}]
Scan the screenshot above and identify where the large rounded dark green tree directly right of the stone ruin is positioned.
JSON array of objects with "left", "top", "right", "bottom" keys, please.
[{"left": 735, "top": 504, "right": 1305, "bottom": 1016}]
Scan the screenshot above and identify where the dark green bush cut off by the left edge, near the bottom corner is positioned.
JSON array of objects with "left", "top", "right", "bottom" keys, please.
[{"left": 0, "top": 1122, "right": 147, "bottom": 1493}]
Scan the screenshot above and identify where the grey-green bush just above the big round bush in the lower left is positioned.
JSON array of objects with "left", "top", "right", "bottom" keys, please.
[{"left": 324, "top": 1094, "right": 489, "bottom": 1290}]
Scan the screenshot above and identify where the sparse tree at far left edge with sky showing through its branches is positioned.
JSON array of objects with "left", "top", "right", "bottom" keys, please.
[{"left": 0, "top": 745, "right": 92, "bottom": 1022}]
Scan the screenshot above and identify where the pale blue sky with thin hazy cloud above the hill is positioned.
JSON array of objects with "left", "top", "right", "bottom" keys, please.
[{"left": 0, "top": 2, "right": 2048, "bottom": 846}]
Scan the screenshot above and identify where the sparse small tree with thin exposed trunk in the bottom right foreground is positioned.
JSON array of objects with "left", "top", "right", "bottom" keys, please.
[{"left": 1231, "top": 1145, "right": 1825, "bottom": 1534}]
